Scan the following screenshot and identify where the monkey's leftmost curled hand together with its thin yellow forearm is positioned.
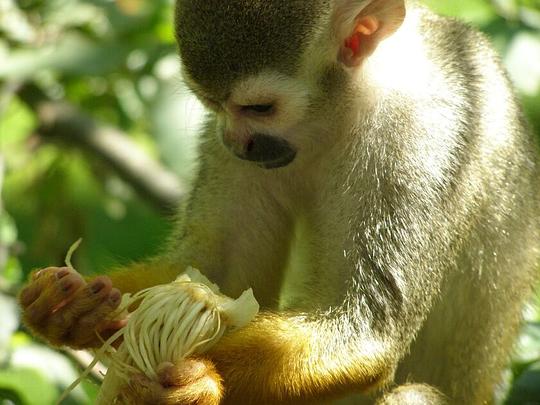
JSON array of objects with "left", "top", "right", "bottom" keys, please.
[{"left": 19, "top": 261, "right": 184, "bottom": 349}]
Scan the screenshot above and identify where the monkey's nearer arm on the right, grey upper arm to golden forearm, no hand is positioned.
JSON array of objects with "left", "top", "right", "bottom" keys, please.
[{"left": 202, "top": 148, "right": 456, "bottom": 404}]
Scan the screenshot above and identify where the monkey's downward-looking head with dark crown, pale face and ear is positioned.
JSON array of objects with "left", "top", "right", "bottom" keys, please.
[{"left": 175, "top": 0, "right": 404, "bottom": 169}]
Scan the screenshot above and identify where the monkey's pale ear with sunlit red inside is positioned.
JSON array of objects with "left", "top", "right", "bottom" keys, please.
[{"left": 334, "top": 0, "right": 405, "bottom": 67}]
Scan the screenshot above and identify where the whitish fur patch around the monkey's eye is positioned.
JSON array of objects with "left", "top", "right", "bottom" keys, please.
[{"left": 229, "top": 72, "right": 309, "bottom": 130}]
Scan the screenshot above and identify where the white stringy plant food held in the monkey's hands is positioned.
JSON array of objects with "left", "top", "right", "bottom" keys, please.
[{"left": 58, "top": 267, "right": 259, "bottom": 405}]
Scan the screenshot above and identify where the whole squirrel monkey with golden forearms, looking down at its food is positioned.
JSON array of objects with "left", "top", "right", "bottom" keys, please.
[{"left": 20, "top": 0, "right": 540, "bottom": 404}]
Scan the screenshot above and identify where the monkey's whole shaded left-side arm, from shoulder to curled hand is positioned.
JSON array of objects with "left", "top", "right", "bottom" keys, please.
[{"left": 20, "top": 133, "right": 289, "bottom": 348}]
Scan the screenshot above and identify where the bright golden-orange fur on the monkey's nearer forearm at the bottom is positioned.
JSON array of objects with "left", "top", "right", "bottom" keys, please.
[{"left": 207, "top": 314, "right": 393, "bottom": 404}]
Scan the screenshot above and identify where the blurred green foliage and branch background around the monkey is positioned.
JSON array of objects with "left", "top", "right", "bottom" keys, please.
[{"left": 0, "top": 0, "right": 540, "bottom": 405}]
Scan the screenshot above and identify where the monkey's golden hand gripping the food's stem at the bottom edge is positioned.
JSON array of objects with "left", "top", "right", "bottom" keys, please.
[{"left": 119, "top": 358, "right": 223, "bottom": 405}]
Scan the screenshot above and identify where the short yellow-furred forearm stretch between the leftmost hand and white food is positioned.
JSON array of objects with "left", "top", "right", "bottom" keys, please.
[{"left": 107, "top": 260, "right": 187, "bottom": 294}]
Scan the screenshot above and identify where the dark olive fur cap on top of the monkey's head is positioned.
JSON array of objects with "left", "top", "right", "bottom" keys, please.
[{"left": 175, "top": 0, "right": 331, "bottom": 100}]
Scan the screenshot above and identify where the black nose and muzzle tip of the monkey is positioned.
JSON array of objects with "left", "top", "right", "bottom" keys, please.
[{"left": 236, "top": 134, "right": 296, "bottom": 169}]
